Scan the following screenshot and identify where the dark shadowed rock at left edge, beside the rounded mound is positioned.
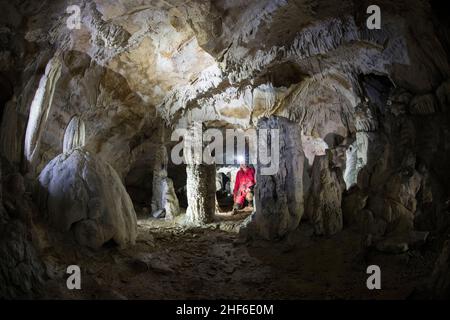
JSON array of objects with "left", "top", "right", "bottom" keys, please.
[{"left": 0, "top": 159, "right": 44, "bottom": 299}]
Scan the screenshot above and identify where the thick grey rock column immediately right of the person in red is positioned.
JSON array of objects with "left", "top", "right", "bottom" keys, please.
[{"left": 252, "top": 117, "right": 305, "bottom": 239}]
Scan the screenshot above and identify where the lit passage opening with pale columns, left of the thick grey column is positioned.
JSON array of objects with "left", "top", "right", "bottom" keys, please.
[{"left": 132, "top": 124, "right": 257, "bottom": 233}]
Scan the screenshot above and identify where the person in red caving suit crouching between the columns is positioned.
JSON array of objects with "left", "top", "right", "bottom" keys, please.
[{"left": 233, "top": 163, "right": 256, "bottom": 211}]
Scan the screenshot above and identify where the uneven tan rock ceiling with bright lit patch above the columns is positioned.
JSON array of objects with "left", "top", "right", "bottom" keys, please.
[{"left": 2, "top": 0, "right": 449, "bottom": 178}]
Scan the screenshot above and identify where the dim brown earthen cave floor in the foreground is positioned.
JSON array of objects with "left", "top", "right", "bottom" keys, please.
[{"left": 40, "top": 220, "right": 434, "bottom": 299}]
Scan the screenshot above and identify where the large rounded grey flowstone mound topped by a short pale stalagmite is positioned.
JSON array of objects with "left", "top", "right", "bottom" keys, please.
[{"left": 39, "top": 117, "right": 137, "bottom": 249}]
